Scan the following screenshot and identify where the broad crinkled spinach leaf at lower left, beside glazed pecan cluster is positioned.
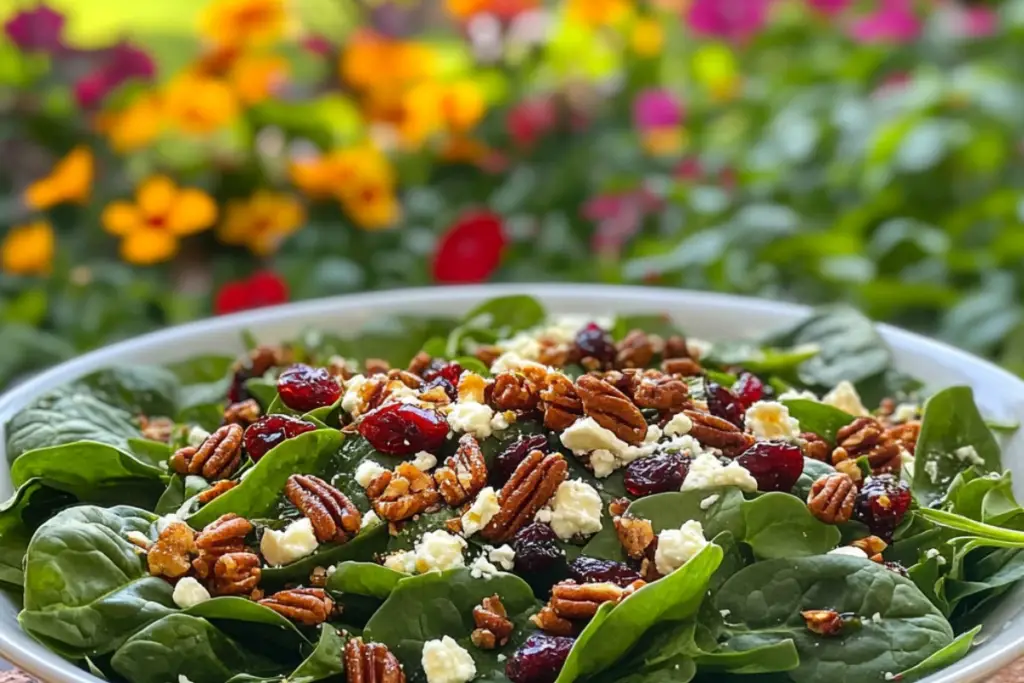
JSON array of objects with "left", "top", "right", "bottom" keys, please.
[{"left": 18, "top": 506, "right": 175, "bottom": 656}]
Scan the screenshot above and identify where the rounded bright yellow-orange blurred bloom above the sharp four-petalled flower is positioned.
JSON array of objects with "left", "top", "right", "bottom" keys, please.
[{"left": 165, "top": 72, "right": 239, "bottom": 135}]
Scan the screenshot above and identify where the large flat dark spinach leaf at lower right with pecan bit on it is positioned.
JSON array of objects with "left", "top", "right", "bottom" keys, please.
[{"left": 714, "top": 555, "right": 953, "bottom": 683}]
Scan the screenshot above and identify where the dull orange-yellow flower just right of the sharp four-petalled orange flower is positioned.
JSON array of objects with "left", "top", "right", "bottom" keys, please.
[{"left": 217, "top": 189, "right": 306, "bottom": 256}]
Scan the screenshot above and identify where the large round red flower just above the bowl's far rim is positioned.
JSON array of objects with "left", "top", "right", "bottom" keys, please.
[{"left": 433, "top": 211, "right": 508, "bottom": 283}]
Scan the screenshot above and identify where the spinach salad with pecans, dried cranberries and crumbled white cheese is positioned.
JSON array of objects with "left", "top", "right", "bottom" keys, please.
[{"left": 0, "top": 296, "right": 1024, "bottom": 683}]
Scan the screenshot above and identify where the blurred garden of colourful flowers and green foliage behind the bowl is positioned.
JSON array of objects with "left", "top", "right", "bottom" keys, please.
[{"left": 0, "top": 0, "right": 1024, "bottom": 386}]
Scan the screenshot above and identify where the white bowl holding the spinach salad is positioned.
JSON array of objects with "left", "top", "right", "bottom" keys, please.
[{"left": 0, "top": 285, "right": 1024, "bottom": 683}]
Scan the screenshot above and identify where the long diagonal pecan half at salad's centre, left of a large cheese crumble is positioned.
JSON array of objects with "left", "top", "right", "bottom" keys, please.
[{"left": 480, "top": 451, "right": 568, "bottom": 545}]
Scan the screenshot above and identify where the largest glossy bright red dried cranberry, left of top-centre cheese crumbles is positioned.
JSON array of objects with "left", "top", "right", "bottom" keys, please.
[{"left": 359, "top": 403, "right": 449, "bottom": 456}]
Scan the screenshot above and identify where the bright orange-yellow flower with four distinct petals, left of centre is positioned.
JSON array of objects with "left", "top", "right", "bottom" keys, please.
[{"left": 101, "top": 175, "right": 217, "bottom": 265}]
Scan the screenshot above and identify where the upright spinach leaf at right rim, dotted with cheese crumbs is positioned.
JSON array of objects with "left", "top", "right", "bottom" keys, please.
[{"left": 913, "top": 387, "right": 1002, "bottom": 506}]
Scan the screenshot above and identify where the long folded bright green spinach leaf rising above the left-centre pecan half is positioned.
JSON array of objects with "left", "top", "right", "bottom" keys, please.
[{"left": 188, "top": 429, "right": 342, "bottom": 528}]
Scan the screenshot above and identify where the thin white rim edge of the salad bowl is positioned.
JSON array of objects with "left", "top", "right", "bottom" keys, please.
[{"left": 0, "top": 283, "right": 1024, "bottom": 683}]
